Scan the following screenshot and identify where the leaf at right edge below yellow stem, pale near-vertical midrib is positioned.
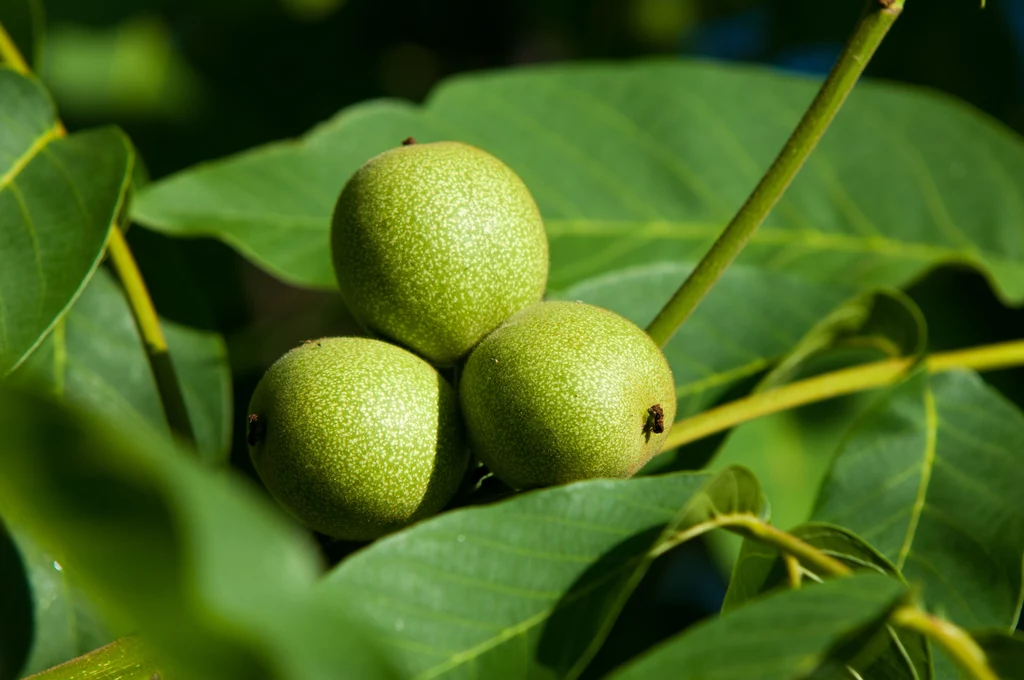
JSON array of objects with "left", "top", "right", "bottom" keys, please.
[{"left": 814, "top": 372, "right": 1024, "bottom": 629}]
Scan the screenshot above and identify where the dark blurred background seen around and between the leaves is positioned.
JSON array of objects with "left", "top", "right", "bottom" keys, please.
[{"left": 8, "top": 0, "right": 1024, "bottom": 675}]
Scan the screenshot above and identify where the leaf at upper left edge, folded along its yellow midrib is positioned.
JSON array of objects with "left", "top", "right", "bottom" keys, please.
[{"left": 0, "top": 68, "right": 134, "bottom": 376}]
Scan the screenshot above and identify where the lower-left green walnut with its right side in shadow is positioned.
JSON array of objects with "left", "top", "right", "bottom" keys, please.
[{"left": 248, "top": 338, "right": 469, "bottom": 541}]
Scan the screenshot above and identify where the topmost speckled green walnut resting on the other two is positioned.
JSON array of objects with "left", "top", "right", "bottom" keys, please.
[{"left": 331, "top": 140, "right": 548, "bottom": 366}]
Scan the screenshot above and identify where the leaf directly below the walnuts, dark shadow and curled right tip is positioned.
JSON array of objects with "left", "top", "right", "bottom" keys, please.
[{"left": 319, "top": 468, "right": 766, "bottom": 678}]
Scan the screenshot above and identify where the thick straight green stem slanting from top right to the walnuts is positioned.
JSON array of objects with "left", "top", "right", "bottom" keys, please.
[{"left": 647, "top": 0, "right": 904, "bottom": 347}]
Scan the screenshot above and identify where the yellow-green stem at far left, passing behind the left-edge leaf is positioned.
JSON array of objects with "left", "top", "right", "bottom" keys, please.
[{"left": 0, "top": 18, "right": 196, "bottom": 444}]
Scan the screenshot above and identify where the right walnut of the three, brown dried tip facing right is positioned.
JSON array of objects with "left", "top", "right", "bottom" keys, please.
[{"left": 459, "top": 302, "right": 676, "bottom": 488}]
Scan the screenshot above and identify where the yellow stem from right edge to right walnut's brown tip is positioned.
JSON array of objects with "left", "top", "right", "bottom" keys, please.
[{"left": 662, "top": 340, "right": 1024, "bottom": 451}]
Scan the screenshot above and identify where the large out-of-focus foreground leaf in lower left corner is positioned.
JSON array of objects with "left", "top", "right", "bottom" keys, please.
[{"left": 0, "top": 390, "right": 392, "bottom": 680}]
